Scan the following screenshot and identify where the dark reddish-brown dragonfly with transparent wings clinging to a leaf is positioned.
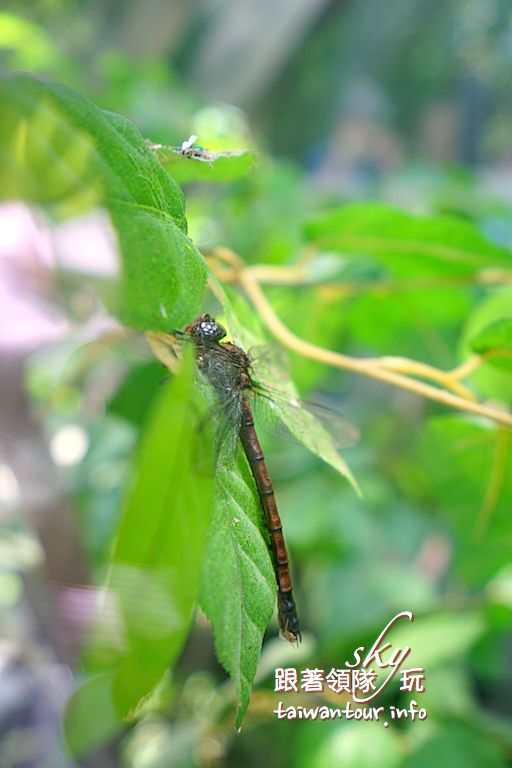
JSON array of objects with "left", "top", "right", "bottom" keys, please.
[{"left": 163, "top": 314, "right": 355, "bottom": 644}]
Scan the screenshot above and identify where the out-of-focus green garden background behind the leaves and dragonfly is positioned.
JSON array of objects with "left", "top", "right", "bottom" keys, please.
[{"left": 0, "top": 0, "right": 512, "bottom": 768}]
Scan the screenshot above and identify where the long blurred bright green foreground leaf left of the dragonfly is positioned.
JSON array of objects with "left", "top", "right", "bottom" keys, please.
[{"left": 68, "top": 357, "right": 213, "bottom": 731}]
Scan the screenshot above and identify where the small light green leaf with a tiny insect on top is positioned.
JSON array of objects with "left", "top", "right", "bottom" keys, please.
[{"left": 155, "top": 148, "right": 256, "bottom": 184}]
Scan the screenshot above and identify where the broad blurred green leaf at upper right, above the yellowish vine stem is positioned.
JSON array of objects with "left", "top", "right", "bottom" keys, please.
[{"left": 304, "top": 203, "right": 512, "bottom": 277}]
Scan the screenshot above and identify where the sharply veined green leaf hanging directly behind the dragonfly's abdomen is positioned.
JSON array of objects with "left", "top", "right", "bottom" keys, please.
[{"left": 201, "top": 452, "right": 276, "bottom": 725}]
